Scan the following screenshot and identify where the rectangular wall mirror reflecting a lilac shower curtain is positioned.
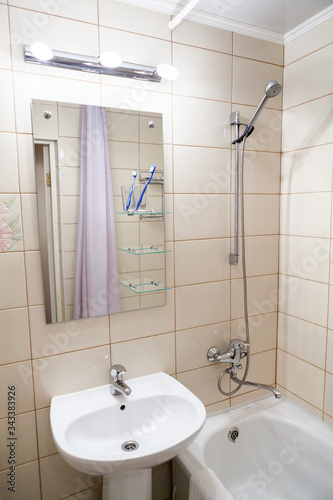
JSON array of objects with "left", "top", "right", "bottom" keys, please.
[{"left": 32, "top": 100, "right": 167, "bottom": 323}]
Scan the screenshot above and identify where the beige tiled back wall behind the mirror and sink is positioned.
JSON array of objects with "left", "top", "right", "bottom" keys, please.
[{"left": 0, "top": 0, "right": 282, "bottom": 500}]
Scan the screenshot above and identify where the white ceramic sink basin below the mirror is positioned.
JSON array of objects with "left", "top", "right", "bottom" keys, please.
[{"left": 51, "top": 372, "right": 206, "bottom": 475}]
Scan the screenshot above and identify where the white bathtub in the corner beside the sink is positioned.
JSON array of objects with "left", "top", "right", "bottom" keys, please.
[{"left": 173, "top": 396, "right": 333, "bottom": 500}]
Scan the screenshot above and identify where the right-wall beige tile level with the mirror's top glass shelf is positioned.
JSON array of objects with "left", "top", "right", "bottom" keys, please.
[{"left": 281, "top": 193, "right": 331, "bottom": 238}]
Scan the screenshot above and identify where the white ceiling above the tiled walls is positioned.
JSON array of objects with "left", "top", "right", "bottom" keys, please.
[{"left": 120, "top": 0, "right": 333, "bottom": 43}]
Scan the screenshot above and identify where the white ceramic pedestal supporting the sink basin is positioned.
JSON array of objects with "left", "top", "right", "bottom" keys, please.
[{"left": 103, "top": 469, "right": 152, "bottom": 500}]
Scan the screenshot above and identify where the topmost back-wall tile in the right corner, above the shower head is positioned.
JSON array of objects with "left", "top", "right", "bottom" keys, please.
[{"left": 233, "top": 33, "right": 283, "bottom": 66}]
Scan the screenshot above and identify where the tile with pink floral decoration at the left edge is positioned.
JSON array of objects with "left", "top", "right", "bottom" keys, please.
[{"left": 0, "top": 194, "right": 23, "bottom": 252}]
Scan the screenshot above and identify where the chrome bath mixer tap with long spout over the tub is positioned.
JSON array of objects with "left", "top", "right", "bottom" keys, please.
[{"left": 207, "top": 339, "right": 282, "bottom": 398}]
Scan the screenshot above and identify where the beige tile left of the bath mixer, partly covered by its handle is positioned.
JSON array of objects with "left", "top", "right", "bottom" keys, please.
[{"left": 176, "top": 322, "right": 230, "bottom": 372}]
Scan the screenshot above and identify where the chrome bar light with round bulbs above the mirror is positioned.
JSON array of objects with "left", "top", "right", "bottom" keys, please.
[{"left": 24, "top": 42, "right": 178, "bottom": 83}]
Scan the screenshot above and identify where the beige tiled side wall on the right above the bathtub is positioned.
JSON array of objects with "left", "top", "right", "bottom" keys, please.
[{"left": 277, "top": 19, "right": 333, "bottom": 424}]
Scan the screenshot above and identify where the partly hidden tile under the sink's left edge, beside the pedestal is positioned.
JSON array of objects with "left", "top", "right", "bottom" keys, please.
[{"left": 40, "top": 455, "right": 101, "bottom": 500}]
